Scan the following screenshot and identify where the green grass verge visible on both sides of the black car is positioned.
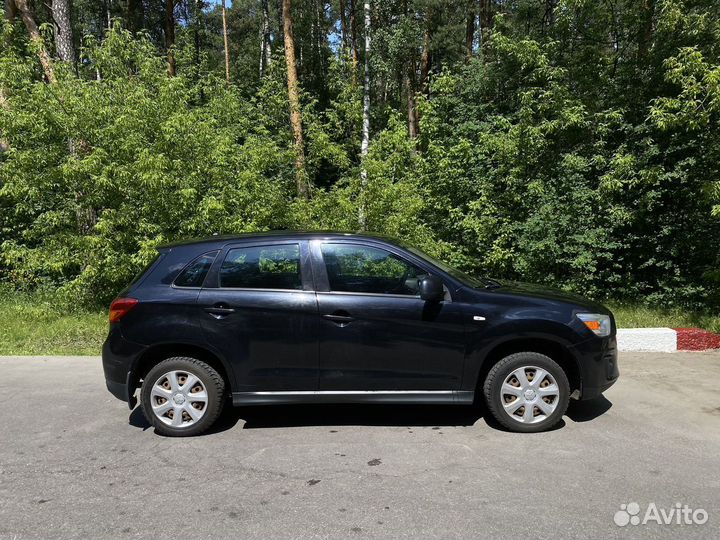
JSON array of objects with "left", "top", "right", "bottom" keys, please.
[{"left": 0, "top": 288, "right": 720, "bottom": 355}]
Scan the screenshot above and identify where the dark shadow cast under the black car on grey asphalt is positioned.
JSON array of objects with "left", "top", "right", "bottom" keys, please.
[{"left": 128, "top": 396, "right": 612, "bottom": 434}]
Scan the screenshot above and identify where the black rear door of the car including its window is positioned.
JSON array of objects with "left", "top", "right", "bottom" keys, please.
[{"left": 198, "top": 241, "right": 318, "bottom": 392}]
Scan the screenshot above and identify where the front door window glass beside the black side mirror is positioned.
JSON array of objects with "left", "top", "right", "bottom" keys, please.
[{"left": 321, "top": 243, "right": 427, "bottom": 296}]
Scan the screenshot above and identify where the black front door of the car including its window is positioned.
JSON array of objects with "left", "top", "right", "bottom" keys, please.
[{"left": 313, "top": 241, "right": 465, "bottom": 391}]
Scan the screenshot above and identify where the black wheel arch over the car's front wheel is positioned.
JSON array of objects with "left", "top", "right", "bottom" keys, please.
[{"left": 475, "top": 336, "right": 582, "bottom": 395}]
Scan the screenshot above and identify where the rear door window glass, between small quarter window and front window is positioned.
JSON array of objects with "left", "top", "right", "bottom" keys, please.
[{"left": 220, "top": 244, "right": 302, "bottom": 290}]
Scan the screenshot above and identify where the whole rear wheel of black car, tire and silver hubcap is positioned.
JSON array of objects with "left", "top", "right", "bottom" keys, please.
[{"left": 141, "top": 357, "right": 225, "bottom": 437}]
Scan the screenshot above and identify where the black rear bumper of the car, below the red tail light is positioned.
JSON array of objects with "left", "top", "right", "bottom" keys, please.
[{"left": 102, "top": 326, "right": 145, "bottom": 409}]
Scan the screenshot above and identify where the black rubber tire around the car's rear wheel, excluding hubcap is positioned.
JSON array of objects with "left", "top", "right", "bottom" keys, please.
[{"left": 140, "top": 356, "right": 225, "bottom": 437}]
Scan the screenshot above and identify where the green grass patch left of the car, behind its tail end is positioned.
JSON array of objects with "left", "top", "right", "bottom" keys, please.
[{"left": 0, "top": 290, "right": 108, "bottom": 355}]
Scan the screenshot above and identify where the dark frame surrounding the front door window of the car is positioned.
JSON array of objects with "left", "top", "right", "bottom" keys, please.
[{"left": 310, "top": 238, "right": 452, "bottom": 303}]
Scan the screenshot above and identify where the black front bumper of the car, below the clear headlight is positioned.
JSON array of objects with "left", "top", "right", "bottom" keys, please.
[{"left": 574, "top": 335, "right": 620, "bottom": 400}]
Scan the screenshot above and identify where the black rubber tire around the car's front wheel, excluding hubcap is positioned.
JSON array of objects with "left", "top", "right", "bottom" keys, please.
[{"left": 483, "top": 352, "right": 570, "bottom": 433}]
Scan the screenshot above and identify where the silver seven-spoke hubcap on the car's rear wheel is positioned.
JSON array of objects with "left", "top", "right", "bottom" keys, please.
[{"left": 150, "top": 371, "right": 208, "bottom": 427}]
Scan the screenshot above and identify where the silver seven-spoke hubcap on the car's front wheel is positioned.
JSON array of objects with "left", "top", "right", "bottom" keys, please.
[{"left": 500, "top": 366, "right": 560, "bottom": 424}]
